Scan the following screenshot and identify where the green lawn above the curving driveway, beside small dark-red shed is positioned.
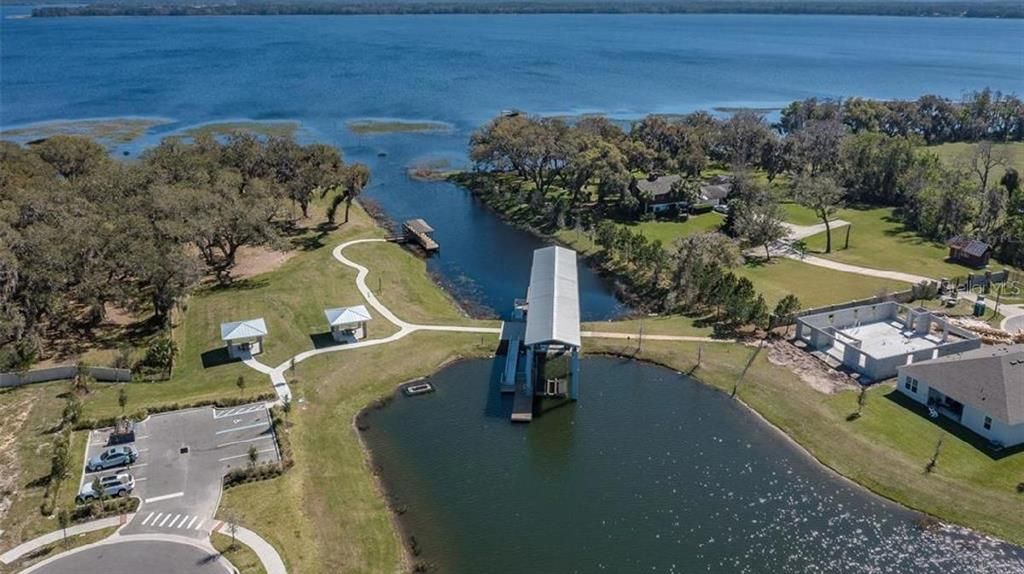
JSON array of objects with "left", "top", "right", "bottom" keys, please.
[{"left": 805, "top": 208, "right": 1019, "bottom": 279}]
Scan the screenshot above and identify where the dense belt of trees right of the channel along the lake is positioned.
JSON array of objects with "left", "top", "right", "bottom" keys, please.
[{"left": 466, "top": 90, "right": 1024, "bottom": 325}]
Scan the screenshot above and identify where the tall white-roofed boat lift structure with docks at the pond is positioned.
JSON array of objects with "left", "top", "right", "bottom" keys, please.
[{"left": 501, "top": 247, "right": 581, "bottom": 423}]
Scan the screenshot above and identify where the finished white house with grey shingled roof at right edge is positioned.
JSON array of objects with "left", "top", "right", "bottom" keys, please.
[{"left": 897, "top": 345, "right": 1024, "bottom": 446}]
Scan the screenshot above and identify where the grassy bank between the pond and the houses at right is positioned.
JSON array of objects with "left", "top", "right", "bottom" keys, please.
[{"left": 587, "top": 340, "right": 1024, "bottom": 543}]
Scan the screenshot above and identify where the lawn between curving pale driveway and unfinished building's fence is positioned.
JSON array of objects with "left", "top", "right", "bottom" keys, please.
[{"left": 735, "top": 257, "right": 910, "bottom": 309}]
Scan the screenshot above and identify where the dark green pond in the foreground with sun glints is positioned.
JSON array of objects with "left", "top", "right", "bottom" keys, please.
[{"left": 364, "top": 358, "right": 1024, "bottom": 574}]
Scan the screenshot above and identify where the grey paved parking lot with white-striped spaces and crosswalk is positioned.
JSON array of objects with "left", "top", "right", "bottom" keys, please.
[{"left": 80, "top": 404, "right": 280, "bottom": 539}]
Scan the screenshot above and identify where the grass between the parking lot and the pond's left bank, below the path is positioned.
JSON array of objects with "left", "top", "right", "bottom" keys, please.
[{"left": 221, "top": 333, "right": 497, "bottom": 574}]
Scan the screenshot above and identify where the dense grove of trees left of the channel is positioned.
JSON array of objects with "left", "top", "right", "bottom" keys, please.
[{"left": 0, "top": 133, "right": 369, "bottom": 370}]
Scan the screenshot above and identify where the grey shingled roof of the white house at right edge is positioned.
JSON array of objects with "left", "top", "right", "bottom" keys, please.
[{"left": 900, "top": 345, "right": 1024, "bottom": 425}]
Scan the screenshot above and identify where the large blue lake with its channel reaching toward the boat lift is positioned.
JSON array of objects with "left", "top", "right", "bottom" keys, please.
[{"left": 0, "top": 11, "right": 1024, "bottom": 319}]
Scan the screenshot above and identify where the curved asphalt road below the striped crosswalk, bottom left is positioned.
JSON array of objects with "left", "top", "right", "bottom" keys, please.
[{"left": 26, "top": 540, "right": 231, "bottom": 574}]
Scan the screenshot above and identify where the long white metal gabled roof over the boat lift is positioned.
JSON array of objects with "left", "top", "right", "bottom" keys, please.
[{"left": 523, "top": 247, "right": 580, "bottom": 347}]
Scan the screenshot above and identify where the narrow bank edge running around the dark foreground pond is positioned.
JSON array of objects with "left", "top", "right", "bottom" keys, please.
[{"left": 352, "top": 354, "right": 1024, "bottom": 571}]
